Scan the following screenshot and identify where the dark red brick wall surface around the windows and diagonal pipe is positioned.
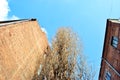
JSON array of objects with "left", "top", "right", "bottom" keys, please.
[{"left": 99, "top": 21, "right": 120, "bottom": 80}]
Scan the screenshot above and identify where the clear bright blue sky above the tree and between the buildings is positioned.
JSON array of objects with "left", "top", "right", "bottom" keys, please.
[{"left": 0, "top": 0, "right": 120, "bottom": 80}]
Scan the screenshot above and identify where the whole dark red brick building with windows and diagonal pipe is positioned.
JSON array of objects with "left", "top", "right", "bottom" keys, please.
[{"left": 99, "top": 19, "right": 120, "bottom": 80}]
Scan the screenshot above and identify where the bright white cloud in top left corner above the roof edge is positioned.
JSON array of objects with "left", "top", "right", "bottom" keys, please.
[{"left": 0, "top": 0, "right": 19, "bottom": 21}]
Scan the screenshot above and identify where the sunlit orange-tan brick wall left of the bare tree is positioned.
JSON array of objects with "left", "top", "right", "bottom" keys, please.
[{"left": 0, "top": 20, "right": 48, "bottom": 80}]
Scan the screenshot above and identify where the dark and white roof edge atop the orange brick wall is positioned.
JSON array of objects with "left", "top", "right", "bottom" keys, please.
[{"left": 0, "top": 18, "right": 37, "bottom": 26}]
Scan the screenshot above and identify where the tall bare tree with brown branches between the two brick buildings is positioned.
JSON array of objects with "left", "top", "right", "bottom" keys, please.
[{"left": 32, "top": 27, "right": 94, "bottom": 80}]
